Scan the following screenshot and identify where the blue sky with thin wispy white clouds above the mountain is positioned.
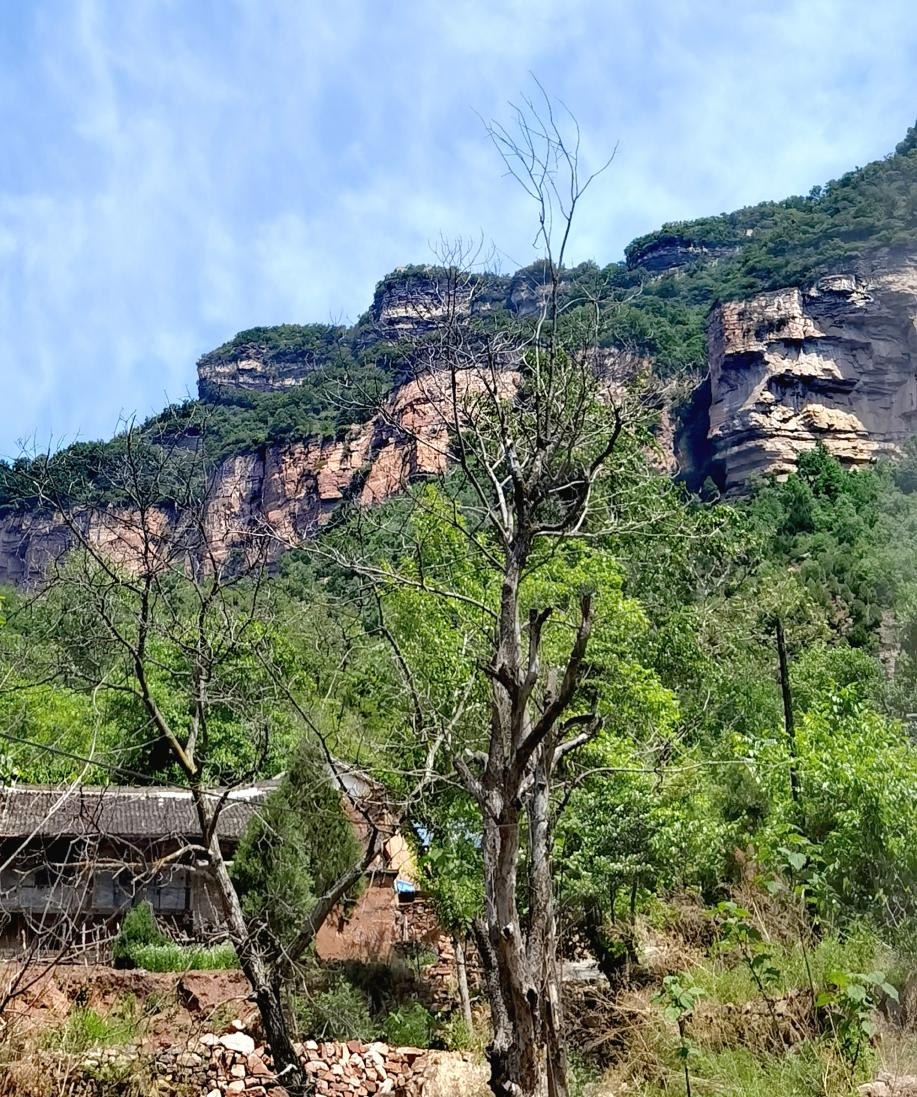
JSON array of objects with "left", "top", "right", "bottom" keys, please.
[{"left": 0, "top": 0, "right": 917, "bottom": 454}]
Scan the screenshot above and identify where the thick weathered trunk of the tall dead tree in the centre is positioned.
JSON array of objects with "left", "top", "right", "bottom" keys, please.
[{"left": 456, "top": 561, "right": 596, "bottom": 1097}]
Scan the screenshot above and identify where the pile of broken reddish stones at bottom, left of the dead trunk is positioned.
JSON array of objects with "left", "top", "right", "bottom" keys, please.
[{"left": 197, "top": 1022, "right": 427, "bottom": 1097}]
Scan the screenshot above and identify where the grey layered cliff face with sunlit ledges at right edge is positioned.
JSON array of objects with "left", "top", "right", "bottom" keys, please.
[{"left": 709, "top": 251, "right": 917, "bottom": 491}]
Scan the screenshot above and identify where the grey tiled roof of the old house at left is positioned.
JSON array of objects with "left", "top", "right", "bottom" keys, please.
[{"left": 0, "top": 784, "right": 270, "bottom": 838}]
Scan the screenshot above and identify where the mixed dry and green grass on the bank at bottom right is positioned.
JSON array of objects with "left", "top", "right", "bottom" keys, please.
[{"left": 595, "top": 917, "right": 917, "bottom": 1097}]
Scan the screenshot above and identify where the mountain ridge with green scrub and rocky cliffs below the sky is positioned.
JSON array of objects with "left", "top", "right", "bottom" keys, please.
[{"left": 0, "top": 127, "right": 917, "bottom": 583}]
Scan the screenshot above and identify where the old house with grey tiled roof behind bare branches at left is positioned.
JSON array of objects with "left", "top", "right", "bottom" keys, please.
[{"left": 0, "top": 785, "right": 269, "bottom": 949}]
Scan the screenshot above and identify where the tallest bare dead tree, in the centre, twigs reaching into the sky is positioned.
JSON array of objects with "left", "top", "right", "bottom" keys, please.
[{"left": 318, "top": 87, "right": 655, "bottom": 1097}]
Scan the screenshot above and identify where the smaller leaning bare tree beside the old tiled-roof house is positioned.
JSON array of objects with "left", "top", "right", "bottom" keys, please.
[{"left": 6, "top": 416, "right": 381, "bottom": 1097}]
